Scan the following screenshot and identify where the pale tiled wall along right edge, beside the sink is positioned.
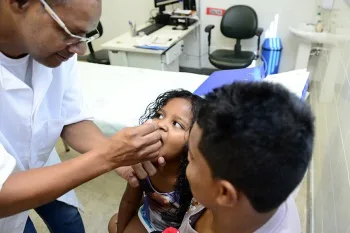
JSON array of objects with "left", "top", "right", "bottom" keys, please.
[{"left": 310, "top": 0, "right": 350, "bottom": 233}]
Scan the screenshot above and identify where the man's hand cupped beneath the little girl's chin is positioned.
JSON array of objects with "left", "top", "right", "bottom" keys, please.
[{"left": 115, "top": 157, "right": 165, "bottom": 188}]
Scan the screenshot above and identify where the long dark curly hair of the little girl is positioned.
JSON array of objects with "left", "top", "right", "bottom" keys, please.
[{"left": 139, "top": 89, "right": 202, "bottom": 219}]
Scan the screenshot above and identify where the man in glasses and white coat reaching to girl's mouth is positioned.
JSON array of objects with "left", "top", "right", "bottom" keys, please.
[{"left": 0, "top": 0, "right": 161, "bottom": 233}]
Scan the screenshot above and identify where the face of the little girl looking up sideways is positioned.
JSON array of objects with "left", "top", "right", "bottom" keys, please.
[{"left": 153, "top": 98, "right": 193, "bottom": 161}]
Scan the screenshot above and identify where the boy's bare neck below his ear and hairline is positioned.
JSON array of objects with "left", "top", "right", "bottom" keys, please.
[{"left": 212, "top": 206, "right": 277, "bottom": 233}]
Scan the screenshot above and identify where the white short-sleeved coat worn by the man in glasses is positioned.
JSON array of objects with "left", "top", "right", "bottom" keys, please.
[{"left": 0, "top": 56, "right": 92, "bottom": 233}]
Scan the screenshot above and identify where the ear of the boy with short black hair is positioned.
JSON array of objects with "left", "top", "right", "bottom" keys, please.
[{"left": 216, "top": 180, "right": 238, "bottom": 208}]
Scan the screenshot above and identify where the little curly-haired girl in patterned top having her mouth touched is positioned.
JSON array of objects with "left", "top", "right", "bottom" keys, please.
[{"left": 110, "top": 90, "right": 201, "bottom": 233}]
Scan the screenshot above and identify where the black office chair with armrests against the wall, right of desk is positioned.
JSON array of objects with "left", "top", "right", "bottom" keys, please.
[{"left": 205, "top": 5, "right": 264, "bottom": 70}]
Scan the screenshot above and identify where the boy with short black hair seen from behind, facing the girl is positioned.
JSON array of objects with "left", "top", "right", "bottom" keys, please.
[{"left": 180, "top": 82, "right": 314, "bottom": 233}]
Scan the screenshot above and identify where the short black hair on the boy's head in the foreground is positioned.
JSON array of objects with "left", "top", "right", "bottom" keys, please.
[{"left": 197, "top": 82, "right": 314, "bottom": 213}]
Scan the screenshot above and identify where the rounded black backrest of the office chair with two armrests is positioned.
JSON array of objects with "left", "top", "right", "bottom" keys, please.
[{"left": 221, "top": 5, "right": 258, "bottom": 40}]
